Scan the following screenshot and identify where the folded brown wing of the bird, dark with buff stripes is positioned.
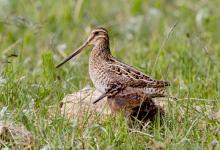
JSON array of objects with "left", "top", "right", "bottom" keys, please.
[{"left": 108, "top": 59, "right": 170, "bottom": 88}]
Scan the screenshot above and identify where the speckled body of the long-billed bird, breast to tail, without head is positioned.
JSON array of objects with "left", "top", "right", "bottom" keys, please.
[{"left": 89, "top": 50, "right": 169, "bottom": 97}]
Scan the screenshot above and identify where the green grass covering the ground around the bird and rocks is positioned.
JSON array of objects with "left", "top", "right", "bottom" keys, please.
[{"left": 0, "top": 0, "right": 220, "bottom": 149}]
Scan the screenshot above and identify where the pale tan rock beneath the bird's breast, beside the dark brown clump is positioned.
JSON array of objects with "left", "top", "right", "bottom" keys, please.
[{"left": 60, "top": 86, "right": 111, "bottom": 119}]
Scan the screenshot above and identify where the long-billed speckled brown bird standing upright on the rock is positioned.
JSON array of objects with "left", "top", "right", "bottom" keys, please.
[{"left": 56, "top": 27, "right": 170, "bottom": 108}]
